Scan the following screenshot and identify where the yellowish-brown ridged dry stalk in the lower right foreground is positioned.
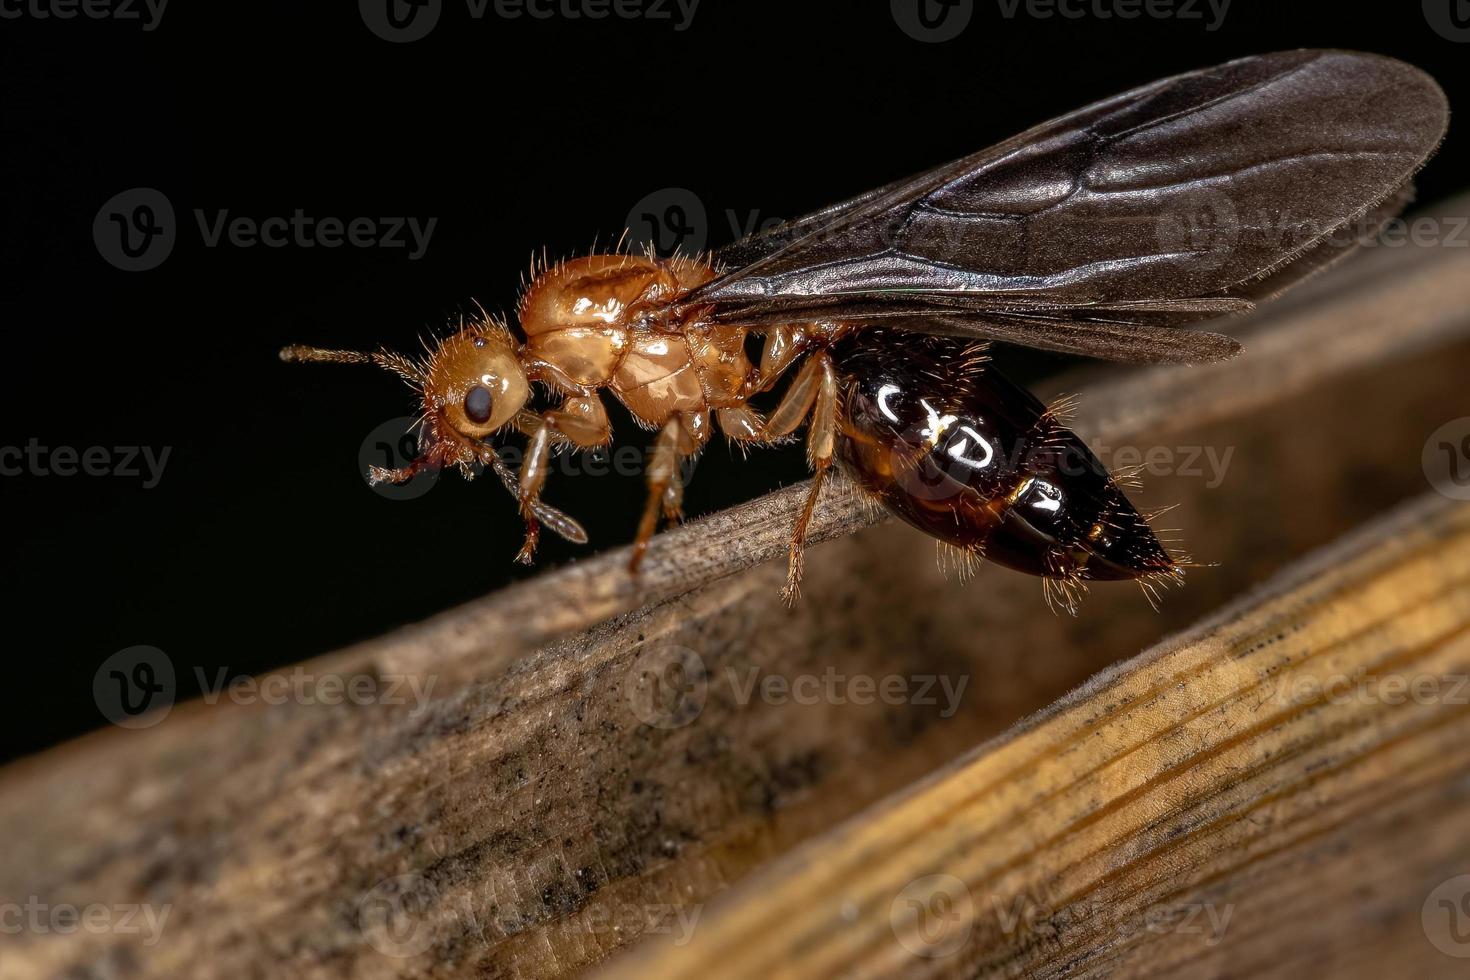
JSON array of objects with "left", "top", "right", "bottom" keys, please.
[{"left": 604, "top": 495, "right": 1470, "bottom": 979}]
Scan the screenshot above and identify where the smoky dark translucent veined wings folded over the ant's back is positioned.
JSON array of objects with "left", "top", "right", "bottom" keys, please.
[{"left": 681, "top": 50, "right": 1448, "bottom": 360}]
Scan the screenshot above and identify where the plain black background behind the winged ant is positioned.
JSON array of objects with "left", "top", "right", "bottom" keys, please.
[{"left": 0, "top": 0, "right": 1470, "bottom": 757}]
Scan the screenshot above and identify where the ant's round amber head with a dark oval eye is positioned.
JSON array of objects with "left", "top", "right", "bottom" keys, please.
[{"left": 423, "top": 319, "right": 531, "bottom": 441}]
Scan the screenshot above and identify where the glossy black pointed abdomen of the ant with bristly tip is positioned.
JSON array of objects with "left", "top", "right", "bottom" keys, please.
[{"left": 833, "top": 329, "right": 1175, "bottom": 579}]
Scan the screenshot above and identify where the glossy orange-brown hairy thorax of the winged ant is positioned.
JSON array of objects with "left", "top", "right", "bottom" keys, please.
[{"left": 519, "top": 254, "right": 756, "bottom": 426}]
